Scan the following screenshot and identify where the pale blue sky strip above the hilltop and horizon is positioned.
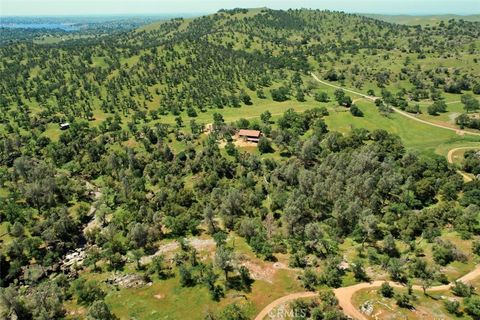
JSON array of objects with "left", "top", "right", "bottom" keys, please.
[{"left": 0, "top": 0, "right": 480, "bottom": 16}]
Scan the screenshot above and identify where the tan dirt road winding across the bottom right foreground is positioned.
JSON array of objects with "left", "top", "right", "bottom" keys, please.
[{"left": 255, "top": 265, "right": 480, "bottom": 320}]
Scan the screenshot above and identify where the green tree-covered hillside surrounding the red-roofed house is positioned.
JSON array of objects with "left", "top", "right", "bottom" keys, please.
[{"left": 0, "top": 9, "right": 480, "bottom": 319}]
